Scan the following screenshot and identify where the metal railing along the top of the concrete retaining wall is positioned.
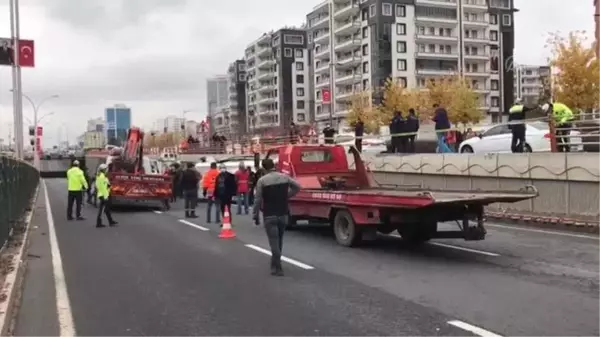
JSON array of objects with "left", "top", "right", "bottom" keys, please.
[{"left": 146, "top": 113, "right": 600, "bottom": 155}]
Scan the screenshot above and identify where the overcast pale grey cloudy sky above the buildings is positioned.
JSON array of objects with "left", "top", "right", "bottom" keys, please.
[{"left": 0, "top": 0, "right": 593, "bottom": 145}]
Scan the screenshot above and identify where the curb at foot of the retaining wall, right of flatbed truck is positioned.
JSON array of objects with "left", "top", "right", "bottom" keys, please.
[{"left": 485, "top": 212, "right": 600, "bottom": 234}]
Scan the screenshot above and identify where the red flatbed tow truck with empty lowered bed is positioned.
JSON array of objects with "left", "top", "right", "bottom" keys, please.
[{"left": 266, "top": 145, "right": 538, "bottom": 246}]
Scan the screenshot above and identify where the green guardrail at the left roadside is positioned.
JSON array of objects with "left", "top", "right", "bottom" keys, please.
[{"left": 0, "top": 156, "right": 40, "bottom": 247}]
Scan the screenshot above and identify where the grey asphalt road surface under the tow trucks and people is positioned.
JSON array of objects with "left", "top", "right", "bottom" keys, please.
[{"left": 15, "top": 180, "right": 600, "bottom": 337}]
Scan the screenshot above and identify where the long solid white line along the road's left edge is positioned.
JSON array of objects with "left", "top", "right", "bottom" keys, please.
[{"left": 42, "top": 180, "right": 76, "bottom": 337}]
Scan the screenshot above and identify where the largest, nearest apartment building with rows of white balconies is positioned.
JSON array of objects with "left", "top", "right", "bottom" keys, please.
[{"left": 307, "top": 0, "right": 515, "bottom": 125}]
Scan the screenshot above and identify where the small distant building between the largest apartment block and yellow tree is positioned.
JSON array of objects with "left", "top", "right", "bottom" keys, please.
[{"left": 514, "top": 65, "right": 551, "bottom": 105}]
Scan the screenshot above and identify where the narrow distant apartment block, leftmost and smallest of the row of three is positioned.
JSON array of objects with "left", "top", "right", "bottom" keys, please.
[{"left": 212, "top": 60, "right": 247, "bottom": 135}]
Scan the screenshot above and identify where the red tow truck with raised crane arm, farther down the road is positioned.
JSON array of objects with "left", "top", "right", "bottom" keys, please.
[{"left": 85, "top": 128, "right": 172, "bottom": 206}]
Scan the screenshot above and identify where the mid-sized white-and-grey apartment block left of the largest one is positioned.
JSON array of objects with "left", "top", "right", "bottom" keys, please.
[{"left": 244, "top": 28, "right": 312, "bottom": 133}]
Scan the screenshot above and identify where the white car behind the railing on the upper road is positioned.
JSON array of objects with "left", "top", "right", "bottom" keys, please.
[{"left": 459, "top": 122, "right": 583, "bottom": 153}]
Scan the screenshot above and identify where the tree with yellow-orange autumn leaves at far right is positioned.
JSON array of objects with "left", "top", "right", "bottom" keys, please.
[{"left": 548, "top": 31, "right": 600, "bottom": 112}]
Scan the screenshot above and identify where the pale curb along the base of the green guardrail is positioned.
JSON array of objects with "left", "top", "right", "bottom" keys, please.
[{"left": 0, "top": 184, "right": 42, "bottom": 337}]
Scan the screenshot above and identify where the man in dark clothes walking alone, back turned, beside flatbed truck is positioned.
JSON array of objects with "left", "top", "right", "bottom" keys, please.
[{"left": 252, "top": 158, "right": 300, "bottom": 276}]
